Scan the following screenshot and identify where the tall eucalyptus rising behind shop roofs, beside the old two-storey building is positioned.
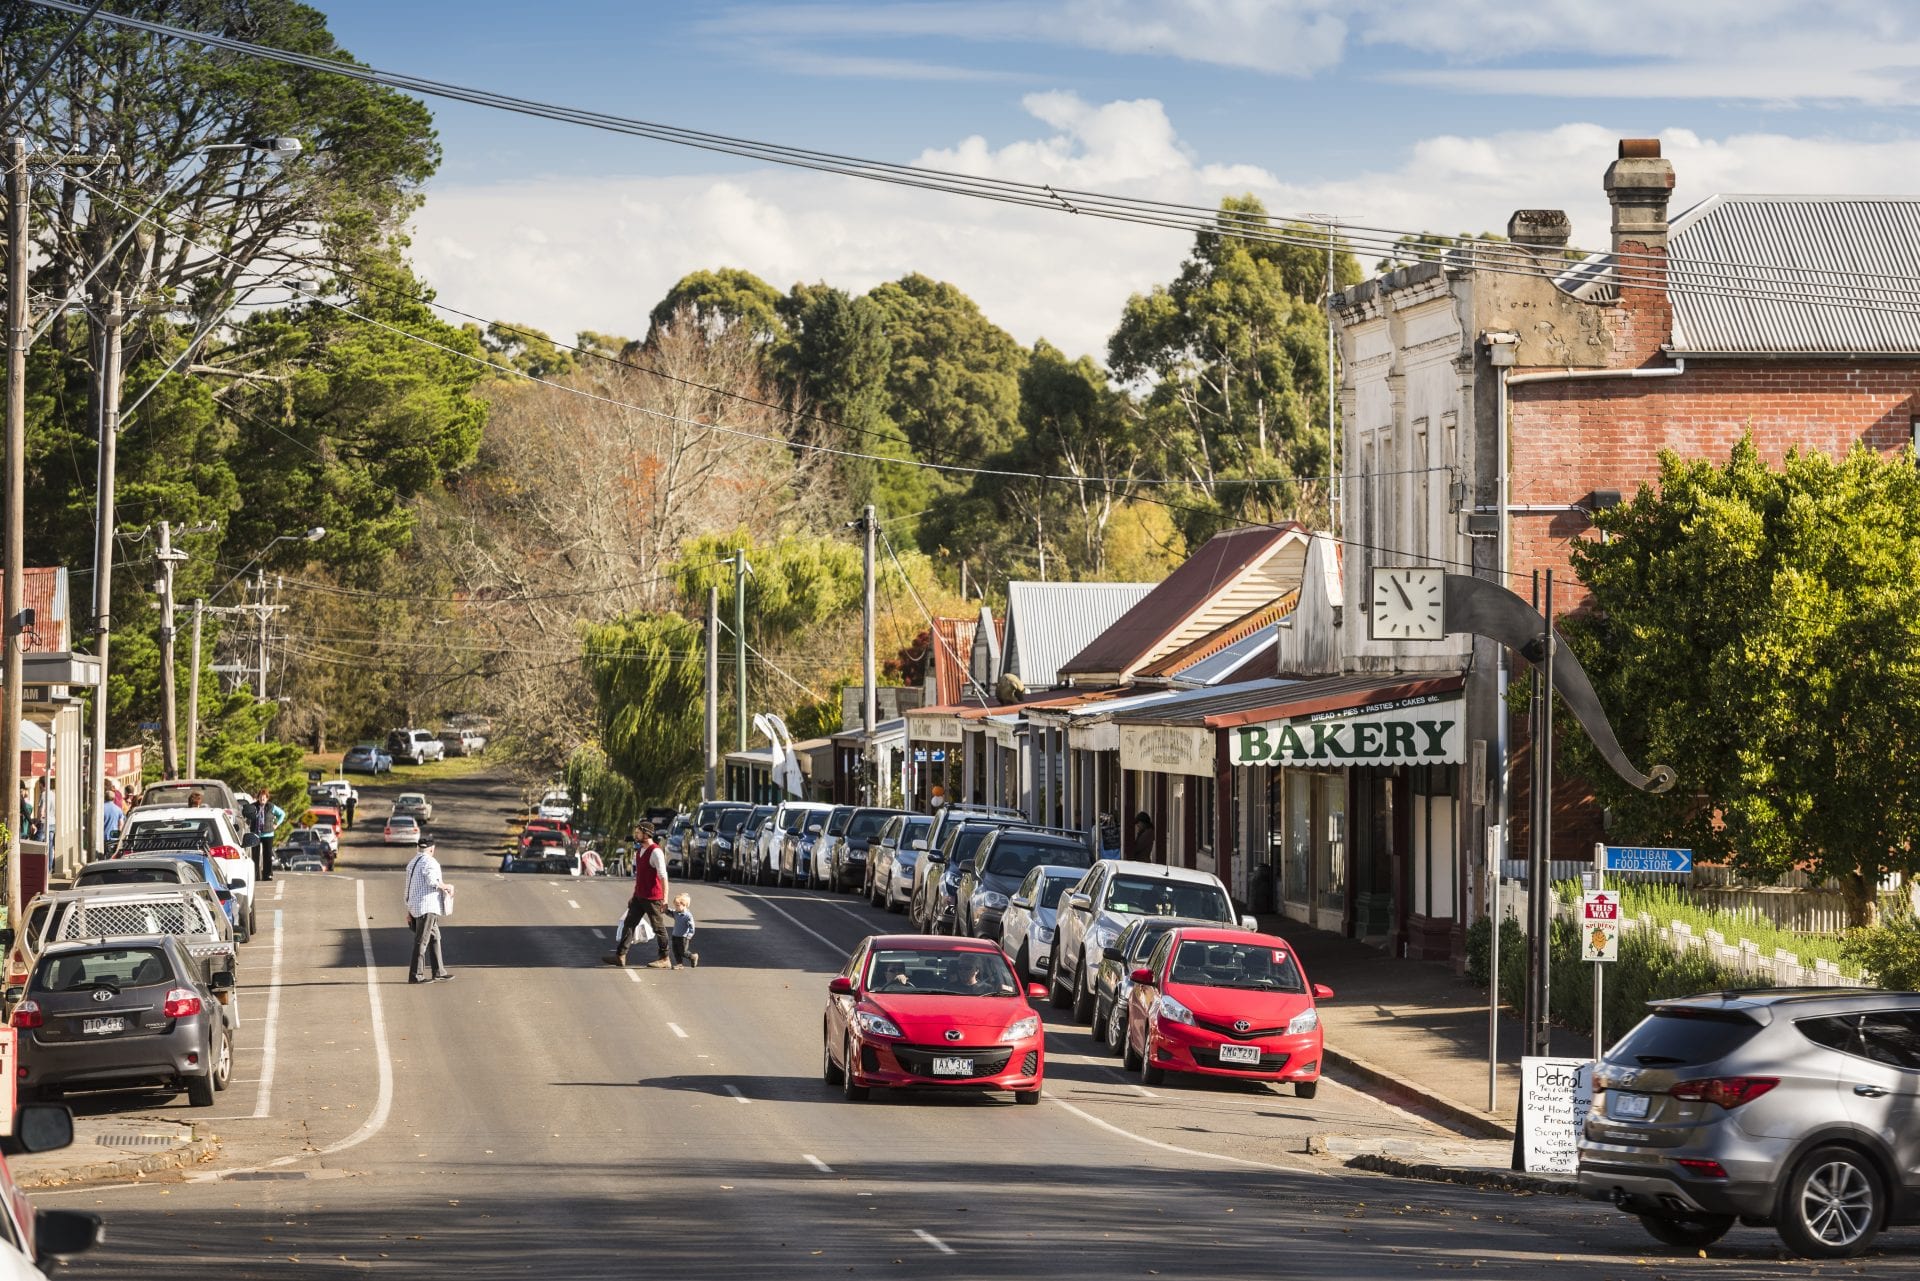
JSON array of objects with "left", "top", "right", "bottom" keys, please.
[{"left": 1108, "top": 196, "right": 1359, "bottom": 544}]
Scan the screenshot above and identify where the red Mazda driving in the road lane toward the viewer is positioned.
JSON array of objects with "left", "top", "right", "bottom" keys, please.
[{"left": 820, "top": 933, "right": 1046, "bottom": 1102}]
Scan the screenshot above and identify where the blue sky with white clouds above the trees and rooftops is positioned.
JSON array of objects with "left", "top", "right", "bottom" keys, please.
[{"left": 295, "top": 0, "right": 1920, "bottom": 359}]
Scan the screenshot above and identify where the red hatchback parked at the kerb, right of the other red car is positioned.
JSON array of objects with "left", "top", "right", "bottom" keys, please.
[{"left": 1125, "top": 926, "right": 1332, "bottom": 1099}]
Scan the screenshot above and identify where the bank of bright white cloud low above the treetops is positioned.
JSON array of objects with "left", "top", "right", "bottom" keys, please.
[{"left": 415, "top": 94, "right": 1920, "bottom": 364}]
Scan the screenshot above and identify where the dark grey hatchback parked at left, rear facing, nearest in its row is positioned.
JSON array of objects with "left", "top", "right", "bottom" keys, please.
[{"left": 13, "top": 935, "right": 234, "bottom": 1108}]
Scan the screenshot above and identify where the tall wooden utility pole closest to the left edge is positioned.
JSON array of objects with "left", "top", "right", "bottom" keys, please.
[{"left": 0, "top": 138, "right": 33, "bottom": 937}]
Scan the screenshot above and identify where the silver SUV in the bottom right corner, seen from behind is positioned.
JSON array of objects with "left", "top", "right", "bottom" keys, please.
[{"left": 1580, "top": 987, "right": 1920, "bottom": 1258}]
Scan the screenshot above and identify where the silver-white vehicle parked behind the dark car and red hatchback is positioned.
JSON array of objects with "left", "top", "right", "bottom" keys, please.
[{"left": 1048, "top": 858, "right": 1256, "bottom": 1022}]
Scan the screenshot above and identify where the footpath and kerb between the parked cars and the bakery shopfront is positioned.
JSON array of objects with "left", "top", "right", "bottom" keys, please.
[{"left": 1260, "top": 916, "right": 1594, "bottom": 1195}]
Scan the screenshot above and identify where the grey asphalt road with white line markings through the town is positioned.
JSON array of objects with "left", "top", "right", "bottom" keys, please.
[{"left": 36, "top": 780, "right": 1920, "bottom": 1281}]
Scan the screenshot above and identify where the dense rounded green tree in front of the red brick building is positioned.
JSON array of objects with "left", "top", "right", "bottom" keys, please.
[{"left": 1565, "top": 438, "right": 1920, "bottom": 924}]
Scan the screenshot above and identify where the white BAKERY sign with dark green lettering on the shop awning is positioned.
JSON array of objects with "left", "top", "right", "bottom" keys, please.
[{"left": 1229, "top": 693, "right": 1467, "bottom": 766}]
